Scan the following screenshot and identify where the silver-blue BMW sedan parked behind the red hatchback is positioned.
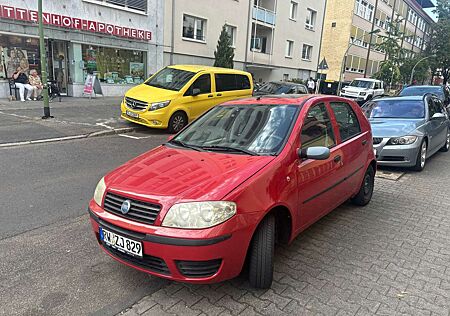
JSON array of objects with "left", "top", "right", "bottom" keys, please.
[{"left": 362, "top": 94, "right": 450, "bottom": 171}]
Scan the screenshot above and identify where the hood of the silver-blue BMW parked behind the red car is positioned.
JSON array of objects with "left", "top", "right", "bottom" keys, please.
[{"left": 369, "top": 119, "right": 425, "bottom": 137}]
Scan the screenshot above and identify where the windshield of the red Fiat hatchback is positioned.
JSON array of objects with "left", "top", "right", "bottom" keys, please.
[{"left": 170, "top": 104, "right": 299, "bottom": 155}]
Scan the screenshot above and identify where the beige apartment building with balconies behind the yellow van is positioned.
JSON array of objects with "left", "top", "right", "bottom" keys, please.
[{"left": 164, "top": 0, "right": 326, "bottom": 82}]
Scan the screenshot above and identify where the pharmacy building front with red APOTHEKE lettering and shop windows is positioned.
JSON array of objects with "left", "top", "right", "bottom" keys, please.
[{"left": 0, "top": 0, "right": 164, "bottom": 98}]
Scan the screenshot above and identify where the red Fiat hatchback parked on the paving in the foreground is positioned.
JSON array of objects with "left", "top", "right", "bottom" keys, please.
[{"left": 89, "top": 95, "right": 376, "bottom": 288}]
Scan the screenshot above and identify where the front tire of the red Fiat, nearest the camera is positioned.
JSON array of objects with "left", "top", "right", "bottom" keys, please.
[{"left": 249, "top": 214, "right": 275, "bottom": 289}]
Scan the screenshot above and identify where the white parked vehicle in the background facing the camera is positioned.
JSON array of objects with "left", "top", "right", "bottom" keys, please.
[{"left": 339, "top": 78, "right": 384, "bottom": 104}]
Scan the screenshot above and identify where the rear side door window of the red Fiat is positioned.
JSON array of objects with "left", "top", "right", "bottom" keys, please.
[{"left": 330, "top": 102, "right": 361, "bottom": 142}]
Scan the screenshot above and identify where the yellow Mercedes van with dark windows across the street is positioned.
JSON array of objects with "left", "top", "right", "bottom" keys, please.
[{"left": 121, "top": 65, "right": 253, "bottom": 133}]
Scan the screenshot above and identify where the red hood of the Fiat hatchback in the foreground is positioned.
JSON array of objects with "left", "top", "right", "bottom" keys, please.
[{"left": 105, "top": 145, "right": 275, "bottom": 204}]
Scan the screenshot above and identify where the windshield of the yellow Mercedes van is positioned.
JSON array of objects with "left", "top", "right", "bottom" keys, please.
[{"left": 145, "top": 67, "right": 195, "bottom": 91}]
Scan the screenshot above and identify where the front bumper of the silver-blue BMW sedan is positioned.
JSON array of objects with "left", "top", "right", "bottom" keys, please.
[{"left": 373, "top": 137, "right": 422, "bottom": 167}]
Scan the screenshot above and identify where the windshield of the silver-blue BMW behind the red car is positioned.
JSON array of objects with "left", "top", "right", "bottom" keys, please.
[{"left": 362, "top": 99, "right": 425, "bottom": 119}]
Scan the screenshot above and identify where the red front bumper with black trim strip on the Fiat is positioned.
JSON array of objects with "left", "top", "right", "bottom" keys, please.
[{"left": 89, "top": 201, "right": 253, "bottom": 283}]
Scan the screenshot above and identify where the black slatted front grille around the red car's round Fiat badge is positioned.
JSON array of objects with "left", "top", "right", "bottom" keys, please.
[{"left": 103, "top": 192, "right": 161, "bottom": 225}]
